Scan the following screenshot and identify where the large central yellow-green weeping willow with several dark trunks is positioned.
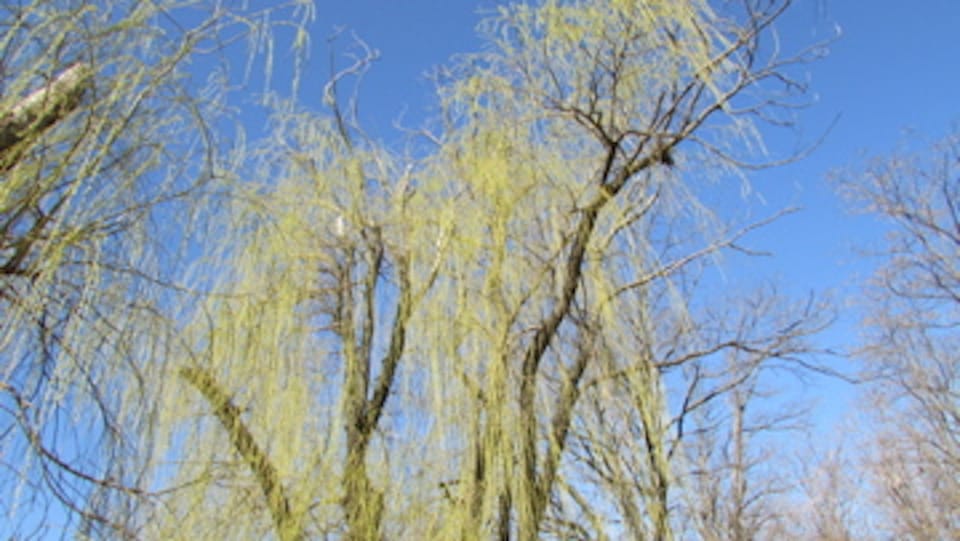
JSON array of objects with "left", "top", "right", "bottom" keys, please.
[{"left": 125, "top": 0, "right": 824, "bottom": 540}]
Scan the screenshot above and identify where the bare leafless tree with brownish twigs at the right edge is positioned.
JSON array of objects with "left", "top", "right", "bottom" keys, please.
[{"left": 842, "top": 129, "right": 960, "bottom": 539}]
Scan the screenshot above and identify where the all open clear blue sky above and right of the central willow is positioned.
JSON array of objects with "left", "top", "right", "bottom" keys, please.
[{"left": 303, "top": 0, "right": 960, "bottom": 429}]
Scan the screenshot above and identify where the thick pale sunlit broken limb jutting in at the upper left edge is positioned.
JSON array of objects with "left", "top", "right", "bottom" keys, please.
[{"left": 0, "top": 62, "right": 92, "bottom": 171}]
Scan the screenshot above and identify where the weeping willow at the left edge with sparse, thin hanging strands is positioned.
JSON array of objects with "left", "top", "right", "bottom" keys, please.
[{"left": 0, "top": 0, "right": 312, "bottom": 539}]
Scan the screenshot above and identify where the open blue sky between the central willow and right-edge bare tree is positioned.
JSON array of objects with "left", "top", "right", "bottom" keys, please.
[{"left": 736, "top": 0, "right": 960, "bottom": 430}]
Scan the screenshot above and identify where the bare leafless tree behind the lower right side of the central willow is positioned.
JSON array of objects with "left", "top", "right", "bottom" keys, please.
[{"left": 572, "top": 284, "right": 830, "bottom": 539}]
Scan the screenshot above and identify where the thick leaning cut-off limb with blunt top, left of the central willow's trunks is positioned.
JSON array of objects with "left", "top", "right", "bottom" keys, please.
[{"left": 180, "top": 367, "right": 304, "bottom": 541}]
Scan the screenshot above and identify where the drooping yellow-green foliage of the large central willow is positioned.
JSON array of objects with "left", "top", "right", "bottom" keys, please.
[{"left": 148, "top": 2, "right": 796, "bottom": 539}]
